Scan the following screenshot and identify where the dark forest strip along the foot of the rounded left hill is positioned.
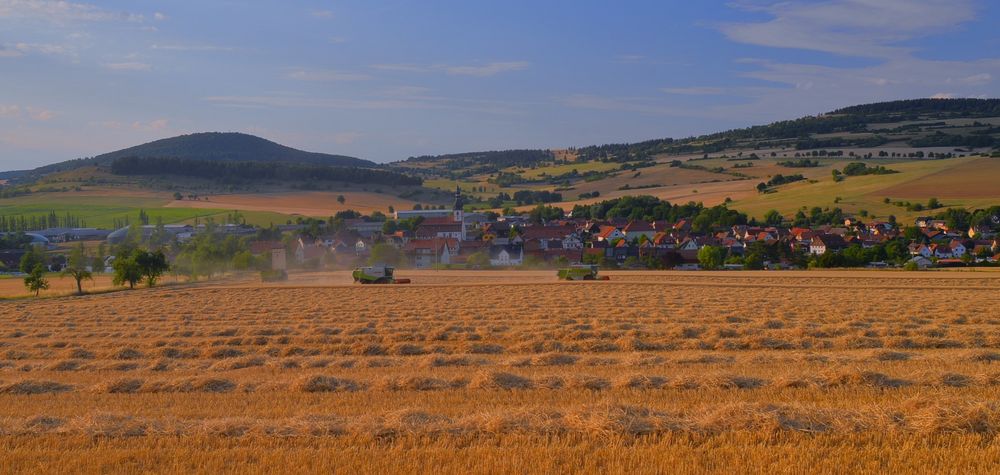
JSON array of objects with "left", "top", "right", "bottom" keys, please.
[{"left": 111, "top": 157, "right": 423, "bottom": 186}]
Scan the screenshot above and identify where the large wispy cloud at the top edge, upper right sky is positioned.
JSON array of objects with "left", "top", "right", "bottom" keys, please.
[{"left": 719, "top": 0, "right": 975, "bottom": 58}]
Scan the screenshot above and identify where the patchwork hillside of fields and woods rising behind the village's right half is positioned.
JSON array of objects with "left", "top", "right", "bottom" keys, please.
[{"left": 390, "top": 99, "right": 1000, "bottom": 223}]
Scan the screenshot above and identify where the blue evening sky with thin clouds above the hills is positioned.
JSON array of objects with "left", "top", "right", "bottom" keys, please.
[{"left": 0, "top": 0, "right": 1000, "bottom": 170}]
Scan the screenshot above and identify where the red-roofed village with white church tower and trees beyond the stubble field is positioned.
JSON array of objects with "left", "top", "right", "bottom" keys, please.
[{"left": 0, "top": 191, "right": 1000, "bottom": 272}]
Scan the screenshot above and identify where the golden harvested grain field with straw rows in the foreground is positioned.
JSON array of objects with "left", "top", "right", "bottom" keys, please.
[{"left": 0, "top": 271, "right": 1000, "bottom": 473}]
